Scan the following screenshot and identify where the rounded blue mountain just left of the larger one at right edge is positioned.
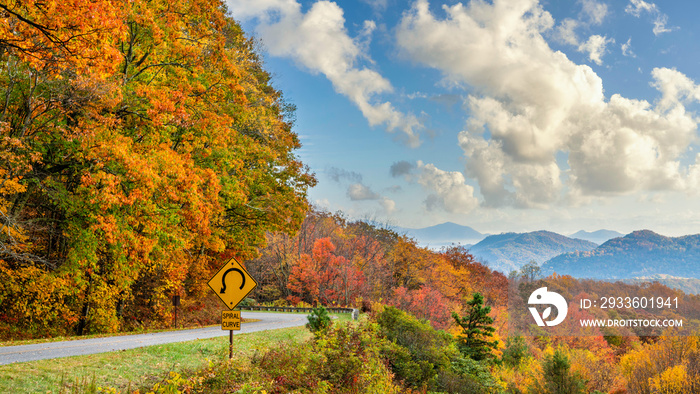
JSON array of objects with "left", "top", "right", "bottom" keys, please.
[{"left": 469, "top": 231, "right": 598, "bottom": 274}]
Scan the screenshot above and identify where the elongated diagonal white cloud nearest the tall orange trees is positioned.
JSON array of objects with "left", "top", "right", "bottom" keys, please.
[{"left": 227, "top": 0, "right": 422, "bottom": 147}]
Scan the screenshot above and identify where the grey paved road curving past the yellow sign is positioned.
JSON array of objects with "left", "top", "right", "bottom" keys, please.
[{"left": 0, "top": 311, "right": 307, "bottom": 365}]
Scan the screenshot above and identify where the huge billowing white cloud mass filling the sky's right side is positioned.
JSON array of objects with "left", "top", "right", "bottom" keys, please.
[{"left": 396, "top": 0, "right": 700, "bottom": 207}]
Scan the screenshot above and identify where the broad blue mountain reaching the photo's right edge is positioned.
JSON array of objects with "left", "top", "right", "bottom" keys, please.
[{"left": 542, "top": 230, "right": 700, "bottom": 279}]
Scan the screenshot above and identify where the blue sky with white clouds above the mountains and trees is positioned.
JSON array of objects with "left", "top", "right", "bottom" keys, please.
[{"left": 227, "top": 0, "right": 700, "bottom": 236}]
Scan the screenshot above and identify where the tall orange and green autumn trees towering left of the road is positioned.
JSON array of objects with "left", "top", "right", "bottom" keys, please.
[{"left": 0, "top": 0, "right": 315, "bottom": 334}]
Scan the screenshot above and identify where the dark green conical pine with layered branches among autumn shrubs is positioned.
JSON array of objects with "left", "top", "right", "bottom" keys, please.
[{"left": 452, "top": 293, "right": 498, "bottom": 361}]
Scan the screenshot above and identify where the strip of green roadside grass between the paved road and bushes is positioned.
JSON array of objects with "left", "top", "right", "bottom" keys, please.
[{"left": 0, "top": 314, "right": 350, "bottom": 394}]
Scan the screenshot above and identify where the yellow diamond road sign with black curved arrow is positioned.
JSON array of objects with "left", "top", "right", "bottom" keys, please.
[{"left": 208, "top": 259, "right": 258, "bottom": 309}]
